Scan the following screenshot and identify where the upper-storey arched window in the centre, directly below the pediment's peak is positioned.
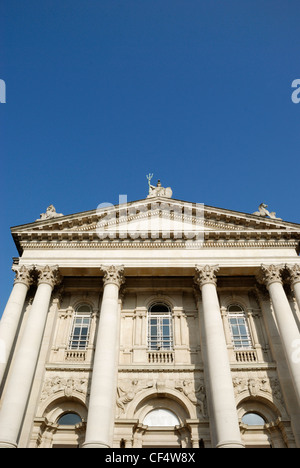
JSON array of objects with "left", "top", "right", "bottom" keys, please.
[{"left": 148, "top": 303, "right": 173, "bottom": 350}]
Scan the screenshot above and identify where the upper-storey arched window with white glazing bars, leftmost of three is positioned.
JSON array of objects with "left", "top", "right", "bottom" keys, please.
[{"left": 69, "top": 304, "right": 92, "bottom": 350}]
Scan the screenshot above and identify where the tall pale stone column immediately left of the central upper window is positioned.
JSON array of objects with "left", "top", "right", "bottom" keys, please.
[{"left": 83, "top": 266, "right": 124, "bottom": 448}]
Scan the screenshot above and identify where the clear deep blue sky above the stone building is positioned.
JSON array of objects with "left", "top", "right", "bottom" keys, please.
[{"left": 0, "top": 0, "right": 300, "bottom": 313}]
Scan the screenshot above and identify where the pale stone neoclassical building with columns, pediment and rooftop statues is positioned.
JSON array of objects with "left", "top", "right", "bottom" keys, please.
[{"left": 0, "top": 182, "right": 300, "bottom": 448}]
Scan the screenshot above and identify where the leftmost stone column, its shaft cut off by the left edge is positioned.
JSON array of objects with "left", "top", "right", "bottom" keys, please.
[{"left": 0, "top": 265, "right": 33, "bottom": 384}]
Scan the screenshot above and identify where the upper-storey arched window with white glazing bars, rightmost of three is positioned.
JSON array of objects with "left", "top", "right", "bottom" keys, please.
[{"left": 228, "top": 304, "right": 252, "bottom": 349}]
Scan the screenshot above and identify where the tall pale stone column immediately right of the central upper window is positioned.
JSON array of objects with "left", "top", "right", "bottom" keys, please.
[{"left": 195, "top": 265, "right": 244, "bottom": 448}]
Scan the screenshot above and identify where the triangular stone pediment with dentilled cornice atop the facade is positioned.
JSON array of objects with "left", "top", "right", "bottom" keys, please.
[{"left": 12, "top": 197, "right": 300, "bottom": 250}]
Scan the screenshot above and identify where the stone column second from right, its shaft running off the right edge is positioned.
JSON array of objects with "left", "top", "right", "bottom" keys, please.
[{"left": 258, "top": 265, "right": 300, "bottom": 405}]
